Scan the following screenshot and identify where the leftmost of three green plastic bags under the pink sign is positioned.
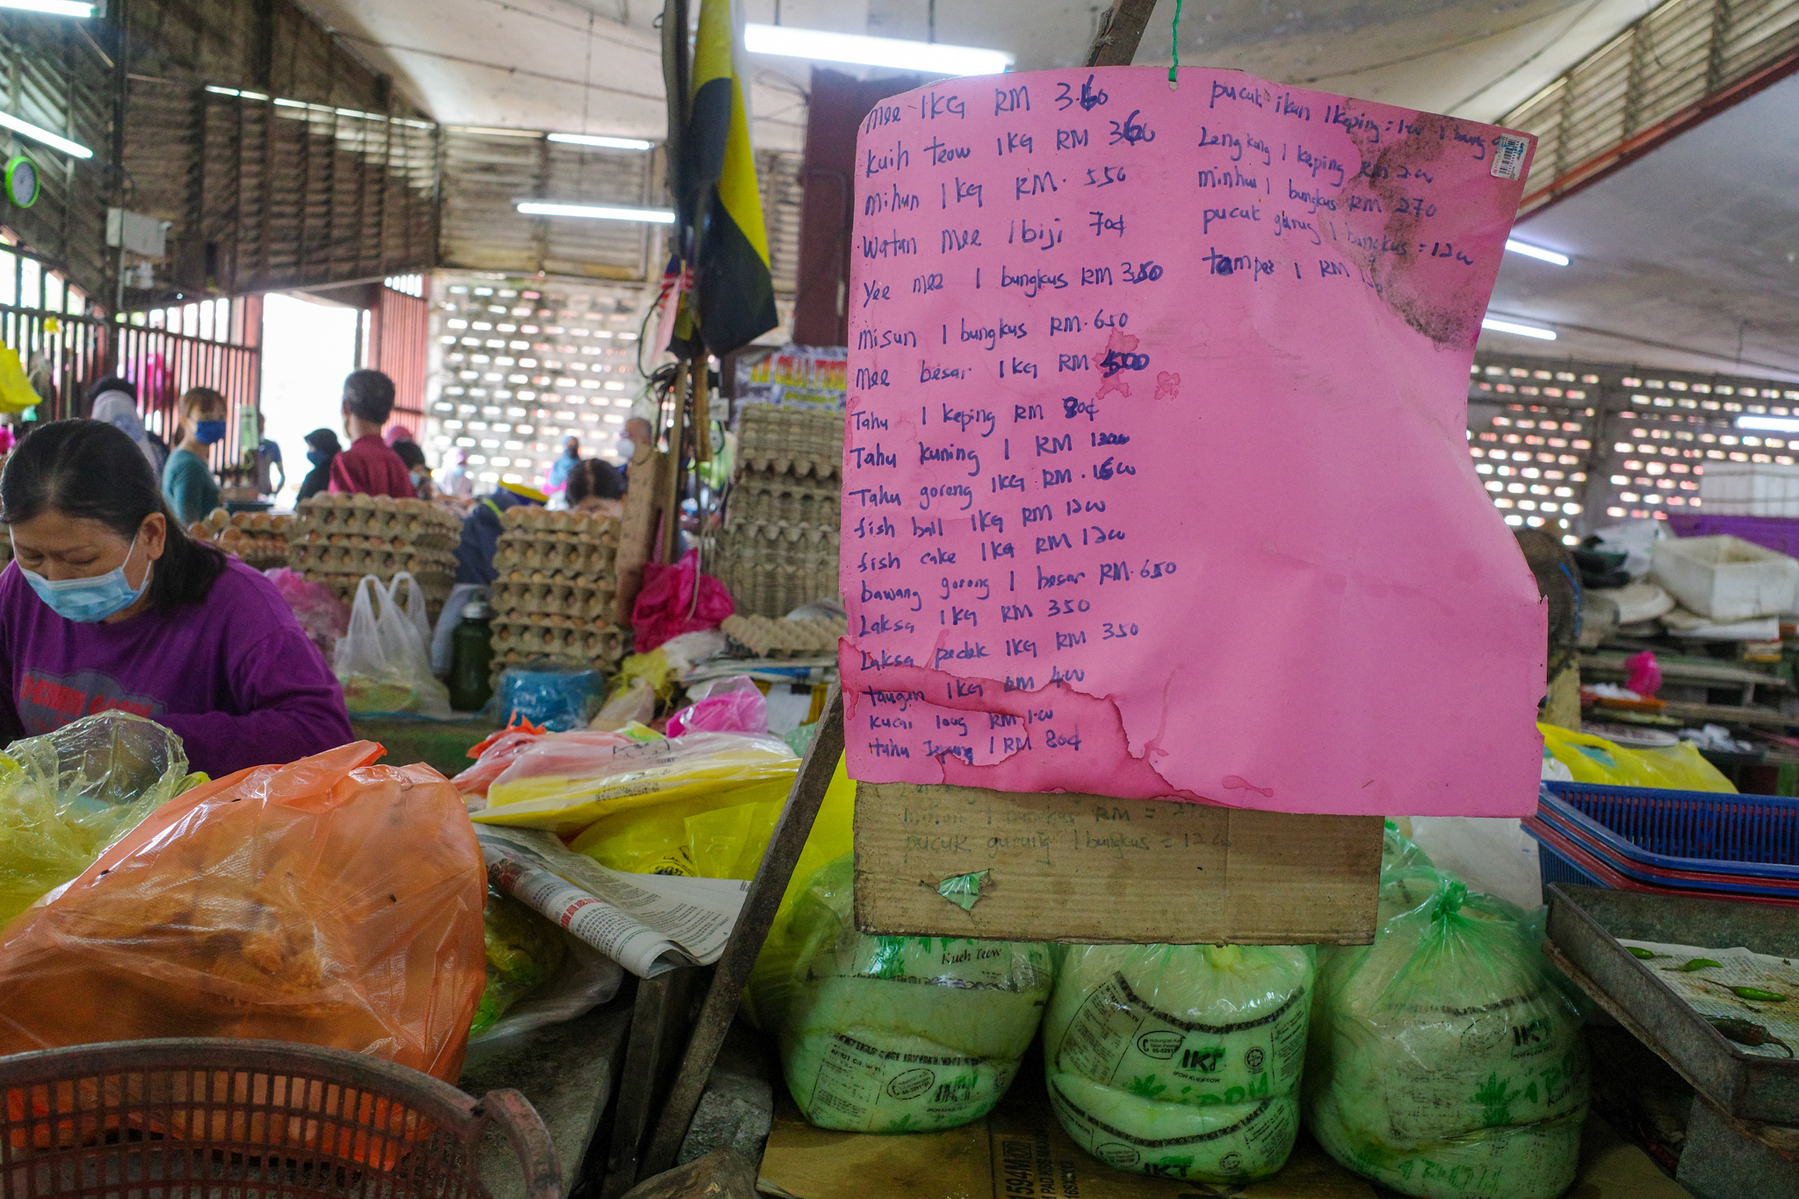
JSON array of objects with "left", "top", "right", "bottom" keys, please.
[{"left": 750, "top": 855, "right": 1051, "bottom": 1132}]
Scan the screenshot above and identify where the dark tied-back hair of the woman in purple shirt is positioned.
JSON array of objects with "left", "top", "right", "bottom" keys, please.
[{"left": 0, "top": 421, "right": 225, "bottom": 610}]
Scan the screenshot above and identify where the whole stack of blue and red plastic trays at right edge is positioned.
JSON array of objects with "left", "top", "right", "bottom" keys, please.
[{"left": 1524, "top": 783, "right": 1799, "bottom": 906}]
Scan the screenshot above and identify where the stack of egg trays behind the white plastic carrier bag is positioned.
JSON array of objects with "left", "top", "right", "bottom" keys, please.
[{"left": 288, "top": 495, "right": 462, "bottom": 618}]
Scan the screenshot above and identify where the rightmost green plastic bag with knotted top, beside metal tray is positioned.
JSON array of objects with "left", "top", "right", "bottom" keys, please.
[{"left": 1304, "top": 868, "right": 1587, "bottom": 1199}]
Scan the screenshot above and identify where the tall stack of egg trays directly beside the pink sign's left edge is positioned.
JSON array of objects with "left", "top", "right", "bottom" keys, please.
[{"left": 716, "top": 403, "right": 844, "bottom": 618}]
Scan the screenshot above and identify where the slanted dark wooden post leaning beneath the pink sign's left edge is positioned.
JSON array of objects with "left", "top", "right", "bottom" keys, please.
[{"left": 637, "top": 686, "right": 844, "bottom": 1179}]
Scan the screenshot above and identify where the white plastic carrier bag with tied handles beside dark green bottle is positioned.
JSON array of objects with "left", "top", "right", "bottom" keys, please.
[{"left": 335, "top": 571, "right": 450, "bottom": 720}]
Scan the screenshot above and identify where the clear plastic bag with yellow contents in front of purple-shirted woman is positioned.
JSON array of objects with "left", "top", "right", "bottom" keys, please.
[{"left": 0, "top": 711, "right": 189, "bottom": 924}]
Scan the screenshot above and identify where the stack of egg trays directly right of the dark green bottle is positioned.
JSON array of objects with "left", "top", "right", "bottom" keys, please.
[{"left": 493, "top": 508, "right": 630, "bottom": 679}]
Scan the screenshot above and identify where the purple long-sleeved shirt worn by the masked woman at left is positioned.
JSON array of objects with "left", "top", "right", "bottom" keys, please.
[{"left": 0, "top": 558, "right": 353, "bottom": 778}]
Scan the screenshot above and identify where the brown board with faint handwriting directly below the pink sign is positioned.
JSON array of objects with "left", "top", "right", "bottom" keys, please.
[{"left": 856, "top": 783, "right": 1382, "bottom": 945}]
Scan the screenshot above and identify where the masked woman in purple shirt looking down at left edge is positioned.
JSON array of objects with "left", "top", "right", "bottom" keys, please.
[{"left": 0, "top": 421, "right": 351, "bottom": 778}]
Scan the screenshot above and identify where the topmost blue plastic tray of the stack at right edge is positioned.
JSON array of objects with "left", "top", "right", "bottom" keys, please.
[{"left": 1538, "top": 783, "right": 1799, "bottom": 882}]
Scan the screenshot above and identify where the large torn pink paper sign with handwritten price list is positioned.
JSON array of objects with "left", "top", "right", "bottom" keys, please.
[{"left": 842, "top": 67, "right": 1545, "bottom": 816}]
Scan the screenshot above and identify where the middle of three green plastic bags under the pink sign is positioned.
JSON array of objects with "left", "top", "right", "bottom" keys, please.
[{"left": 1043, "top": 945, "right": 1313, "bottom": 1183}]
